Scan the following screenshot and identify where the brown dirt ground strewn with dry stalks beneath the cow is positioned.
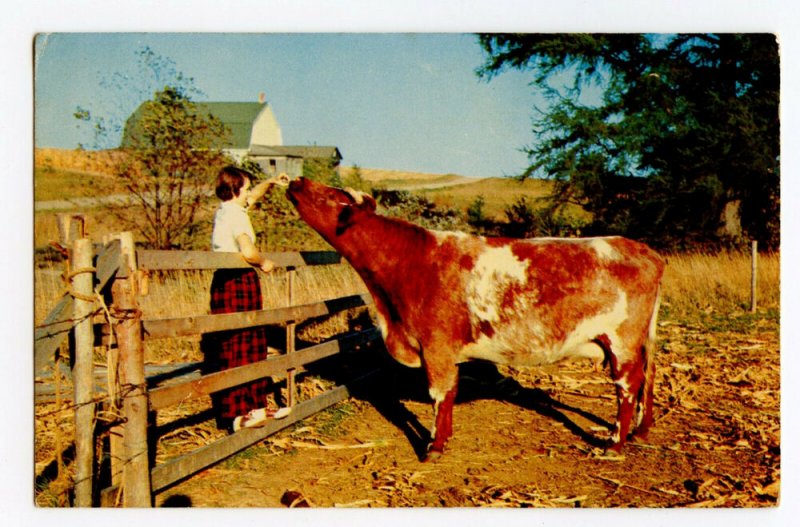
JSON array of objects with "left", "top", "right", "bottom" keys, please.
[{"left": 156, "top": 313, "right": 781, "bottom": 507}]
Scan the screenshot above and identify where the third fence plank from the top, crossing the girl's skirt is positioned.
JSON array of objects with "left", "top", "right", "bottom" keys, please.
[{"left": 149, "top": 329, "right": 379, "bottom": 410}]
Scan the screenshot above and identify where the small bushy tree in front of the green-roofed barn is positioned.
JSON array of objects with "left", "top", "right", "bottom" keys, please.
[{"left": 75, "top": 48, "right": 230, "bottom": 249}]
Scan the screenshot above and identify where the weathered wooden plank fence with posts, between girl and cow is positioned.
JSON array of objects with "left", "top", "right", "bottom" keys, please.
[{"left": 34, "top": 218, "right": 379, "bottom": 507}]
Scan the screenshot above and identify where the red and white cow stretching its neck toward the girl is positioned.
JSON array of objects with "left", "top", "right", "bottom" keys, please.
[{"left": 287, "top": 178, "right": 664, "bottom": 458}]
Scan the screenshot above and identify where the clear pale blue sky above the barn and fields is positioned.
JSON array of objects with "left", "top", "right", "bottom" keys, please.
[{"left": 35, "top": 33, "right": 541, "bottom": 177}]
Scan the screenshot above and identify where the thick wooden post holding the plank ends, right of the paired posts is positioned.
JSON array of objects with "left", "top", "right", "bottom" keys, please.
[{"left": 111, "top": 232, "right": 152, "bottom": 507}]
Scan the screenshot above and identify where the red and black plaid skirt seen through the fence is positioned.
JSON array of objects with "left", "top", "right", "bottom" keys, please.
[{"left": 201, "top": 269, "right": 272, "bottom": 428}]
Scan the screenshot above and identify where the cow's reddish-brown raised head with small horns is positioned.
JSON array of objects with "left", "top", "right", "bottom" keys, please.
[{"left": 286, "top": 178, "right": 377, "bottom": 241}]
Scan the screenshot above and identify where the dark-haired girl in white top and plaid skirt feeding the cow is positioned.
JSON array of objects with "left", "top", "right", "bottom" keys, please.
[{"left": 203, "top": 166, "right": 289, "bottom": 432}]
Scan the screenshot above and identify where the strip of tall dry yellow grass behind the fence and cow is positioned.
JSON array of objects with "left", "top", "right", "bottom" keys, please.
[{"left": 34, "top": 252, "right": 780, "bottom": 360}]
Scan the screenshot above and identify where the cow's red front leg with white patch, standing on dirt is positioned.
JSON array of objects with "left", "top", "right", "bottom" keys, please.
[{"left": 425, "top": 354, "right": 458, "bottom": 461}]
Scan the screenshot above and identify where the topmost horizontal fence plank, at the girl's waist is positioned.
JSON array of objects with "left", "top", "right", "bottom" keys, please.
[{"left": 137, "top": 250, "right": 342, "bottom": 271}]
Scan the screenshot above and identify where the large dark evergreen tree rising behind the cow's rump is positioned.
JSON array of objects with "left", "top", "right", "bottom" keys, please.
[{"left": 478, "top": 34, "right": 780, "bottom": 251}]
